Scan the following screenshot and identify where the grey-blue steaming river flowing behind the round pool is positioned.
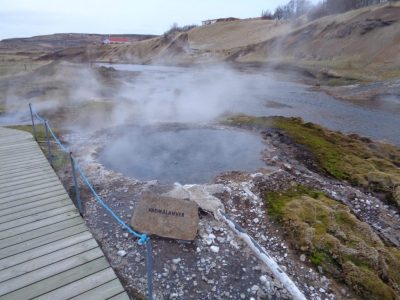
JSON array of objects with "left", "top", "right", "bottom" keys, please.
[{"left": 100, "top": 65, "right": 400, "bottom": 145}]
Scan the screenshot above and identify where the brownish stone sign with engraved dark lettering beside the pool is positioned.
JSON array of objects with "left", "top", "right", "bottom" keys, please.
[{"left": 131, "top": 194, "right": 199, "bottom": 240}]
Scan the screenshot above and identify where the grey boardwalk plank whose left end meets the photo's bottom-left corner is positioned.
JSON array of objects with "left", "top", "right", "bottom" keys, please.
[{"left": 0, "top": 248, "right": 103, "bottom": 299}]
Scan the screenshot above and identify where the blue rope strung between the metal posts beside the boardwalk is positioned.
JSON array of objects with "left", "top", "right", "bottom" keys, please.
[{"left": 33, "top": 105, "right": 149, "bottom": 245}]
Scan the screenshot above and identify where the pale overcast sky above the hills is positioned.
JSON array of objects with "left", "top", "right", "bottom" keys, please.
[{"left": 0, "top": 0, "right": 318, "bottom": 40}]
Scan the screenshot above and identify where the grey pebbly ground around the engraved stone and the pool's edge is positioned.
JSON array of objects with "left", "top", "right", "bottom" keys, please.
[{"left": 54, "top": 122, "right": 400, "bottom": 299}]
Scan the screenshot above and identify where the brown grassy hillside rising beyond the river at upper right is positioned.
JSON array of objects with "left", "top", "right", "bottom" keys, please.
[{"left": 86, "top": 3, "right": 400, "bottom": 81}]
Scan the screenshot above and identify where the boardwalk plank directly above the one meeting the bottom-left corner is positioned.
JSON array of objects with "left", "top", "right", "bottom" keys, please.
[{"left": 0, "top": 239, "right": 98, "bottom": 282}]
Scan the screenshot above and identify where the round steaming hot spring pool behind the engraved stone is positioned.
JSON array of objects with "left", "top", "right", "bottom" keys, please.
[{"left": 98, "top": 128, "right": 265, "bottom": 184}]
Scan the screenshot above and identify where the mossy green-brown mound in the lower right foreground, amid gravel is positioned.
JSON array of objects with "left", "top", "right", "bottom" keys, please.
[{"left": 265, "top": 186, "right": 400, "bottom": 299}]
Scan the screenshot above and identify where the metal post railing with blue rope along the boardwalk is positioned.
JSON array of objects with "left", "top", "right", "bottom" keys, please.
[{"left": 29, "top": 103, "right": 153, "bottom": 300}]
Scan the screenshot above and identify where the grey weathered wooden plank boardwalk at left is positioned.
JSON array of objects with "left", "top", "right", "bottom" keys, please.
[{"left": 0, "top": 127, "right": 129, "bottom": 300}]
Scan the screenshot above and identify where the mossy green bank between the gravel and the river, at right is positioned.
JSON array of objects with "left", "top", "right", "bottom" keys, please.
[{"left": 226, "top": 116, "right": 400, "bottom": 207}]
